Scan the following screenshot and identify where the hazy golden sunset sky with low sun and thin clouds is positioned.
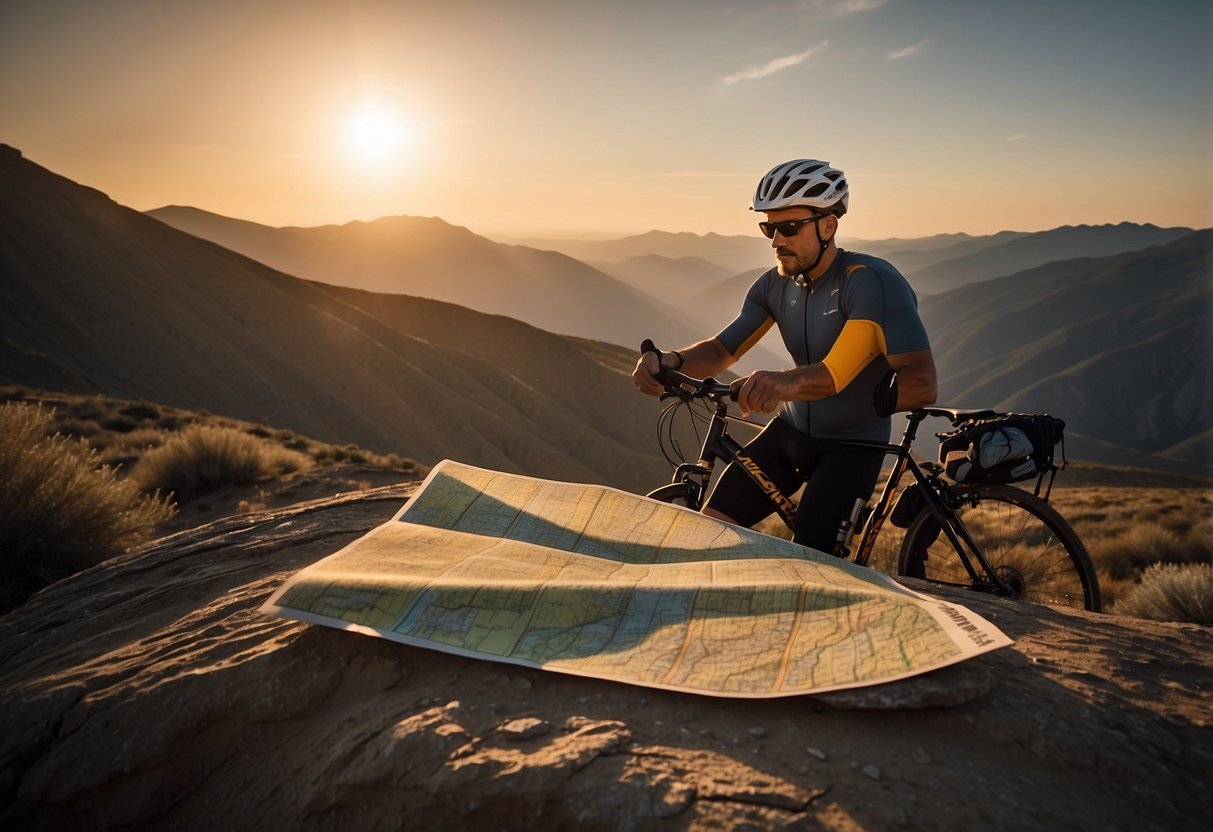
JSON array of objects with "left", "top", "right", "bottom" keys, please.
[{"left": 0, "top": 0, "right": 1213, "bottom": 239}]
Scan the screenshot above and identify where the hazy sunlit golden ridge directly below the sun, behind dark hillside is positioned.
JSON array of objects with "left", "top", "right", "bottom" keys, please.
[{"left": 148, "top": 206, "right": 700, "bottom": 354}]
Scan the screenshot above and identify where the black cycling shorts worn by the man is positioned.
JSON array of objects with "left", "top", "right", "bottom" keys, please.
[{"left": 706, "top": 417, "right": 884, "bottom": 552}]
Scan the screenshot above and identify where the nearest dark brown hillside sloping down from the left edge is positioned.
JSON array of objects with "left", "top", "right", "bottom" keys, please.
[{"left": 0, "top": 148, "right": 668, "bottom": 489}]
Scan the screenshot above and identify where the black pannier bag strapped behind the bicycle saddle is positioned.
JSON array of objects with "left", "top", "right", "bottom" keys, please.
[{"left": 938, "top": 414, "right": 1065, "bottom": 483}]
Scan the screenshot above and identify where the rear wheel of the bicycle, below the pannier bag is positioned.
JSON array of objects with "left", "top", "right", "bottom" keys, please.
[{"left": 898, "top": 485, "right": 1101, "bottom": 612}]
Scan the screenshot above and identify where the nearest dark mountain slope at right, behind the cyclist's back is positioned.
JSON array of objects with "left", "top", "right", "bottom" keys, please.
[{"left": 921, "top": 232, "right": 1213, "bottom": 474}]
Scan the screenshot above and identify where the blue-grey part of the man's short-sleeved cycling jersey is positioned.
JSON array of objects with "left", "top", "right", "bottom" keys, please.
[{"left": 716, "top": 250, "right": 930, "bottom": 441}]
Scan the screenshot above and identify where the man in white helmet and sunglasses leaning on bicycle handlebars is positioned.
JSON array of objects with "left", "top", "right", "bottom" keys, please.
[{"left": 632, "top": 159, "right": 936, "bottom": 552}]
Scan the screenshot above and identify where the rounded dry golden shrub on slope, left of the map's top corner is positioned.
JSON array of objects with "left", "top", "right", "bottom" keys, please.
[{"left": 131, "top": 426, "right": 312, "bottom": 502}]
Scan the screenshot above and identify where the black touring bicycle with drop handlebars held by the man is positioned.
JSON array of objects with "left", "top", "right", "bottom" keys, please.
[{"left": 647, "top": 351, "right": 1101, "bottom": 612}]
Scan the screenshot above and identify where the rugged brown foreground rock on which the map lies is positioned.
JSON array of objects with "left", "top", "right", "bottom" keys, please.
[{"left": 0, "top": 485, "right": 1213, "bottom": 832}]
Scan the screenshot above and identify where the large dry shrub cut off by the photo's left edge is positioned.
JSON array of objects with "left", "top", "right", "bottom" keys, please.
[{"left": 0, "top": 403, "right": 172, "bottom": 612}]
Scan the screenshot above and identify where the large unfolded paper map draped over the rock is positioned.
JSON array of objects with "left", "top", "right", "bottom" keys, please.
[{"left": 263, "top": 461, "right": 1010, "bottom": 697}]
